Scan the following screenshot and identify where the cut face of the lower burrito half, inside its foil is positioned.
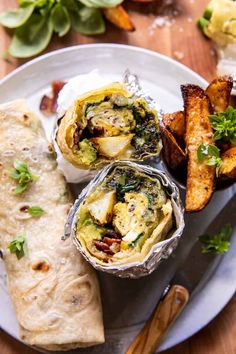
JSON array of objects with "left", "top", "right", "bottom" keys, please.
[{"left": 76, "top": 166, "right": 173, "bottom": 265}]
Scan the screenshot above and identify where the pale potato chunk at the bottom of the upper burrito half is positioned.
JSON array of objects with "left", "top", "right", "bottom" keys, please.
[{"left": 90, "top": 134, "right": 134, "bottom": 158}]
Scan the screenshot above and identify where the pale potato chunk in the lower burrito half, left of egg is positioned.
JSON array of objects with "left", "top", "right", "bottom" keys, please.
[{"left": 88, "top": 190, "right": 116, "bottom": 225}]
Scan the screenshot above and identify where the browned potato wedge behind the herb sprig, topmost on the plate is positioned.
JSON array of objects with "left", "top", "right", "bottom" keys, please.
[{"left": 206, "top": 76, "right": 233, "bottom": 113}]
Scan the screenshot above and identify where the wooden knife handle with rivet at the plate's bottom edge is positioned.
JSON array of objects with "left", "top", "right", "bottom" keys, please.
[{"left": 126, "top": 285, "right": 189, "bottom": 354}]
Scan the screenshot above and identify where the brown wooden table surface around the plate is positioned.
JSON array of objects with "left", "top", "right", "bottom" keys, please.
[{"left": 0, "top": 0, "right": 236, "bottom": 354}]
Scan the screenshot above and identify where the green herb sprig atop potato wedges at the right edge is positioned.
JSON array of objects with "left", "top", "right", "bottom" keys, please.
[{"left": 209, "top": 106, "right": 236, "bottom": 145}]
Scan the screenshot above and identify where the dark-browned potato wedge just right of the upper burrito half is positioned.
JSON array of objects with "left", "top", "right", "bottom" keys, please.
[{"left": 161, "top": 126, "right": 186, "bottom": 170}]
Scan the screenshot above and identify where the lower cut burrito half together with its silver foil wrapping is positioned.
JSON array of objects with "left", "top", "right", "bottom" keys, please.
[{"left": 66, "top": 161, "right": 184, "bottom": 278}]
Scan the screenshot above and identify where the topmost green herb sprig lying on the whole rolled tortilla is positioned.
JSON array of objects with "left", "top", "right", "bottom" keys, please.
[{"left": 9, "top": 160, "right": 37, "bottom": 194}]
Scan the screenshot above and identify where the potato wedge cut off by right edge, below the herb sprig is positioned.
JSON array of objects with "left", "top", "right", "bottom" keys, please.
[{"left": 219, "top": 146, "right": 236, "bottom": 179}]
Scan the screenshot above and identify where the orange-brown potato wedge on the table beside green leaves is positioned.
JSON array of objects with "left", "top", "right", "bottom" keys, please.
[{"left": 103, "top": 5, "right": 135, "bottom": 32}]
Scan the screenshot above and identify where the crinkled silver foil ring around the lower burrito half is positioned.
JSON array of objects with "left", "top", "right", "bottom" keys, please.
[{"left": 65, "top": 161, "right": 185, "bottom": 279}]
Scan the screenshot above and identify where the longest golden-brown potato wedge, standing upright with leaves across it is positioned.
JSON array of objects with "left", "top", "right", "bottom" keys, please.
[{"left": 181, "top": 85, "right": 215, "bottom": 212}]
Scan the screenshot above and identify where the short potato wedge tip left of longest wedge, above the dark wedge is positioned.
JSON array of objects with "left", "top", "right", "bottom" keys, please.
[{"left": 163, "top": 111, "right": 185, "bottom": 140}]
